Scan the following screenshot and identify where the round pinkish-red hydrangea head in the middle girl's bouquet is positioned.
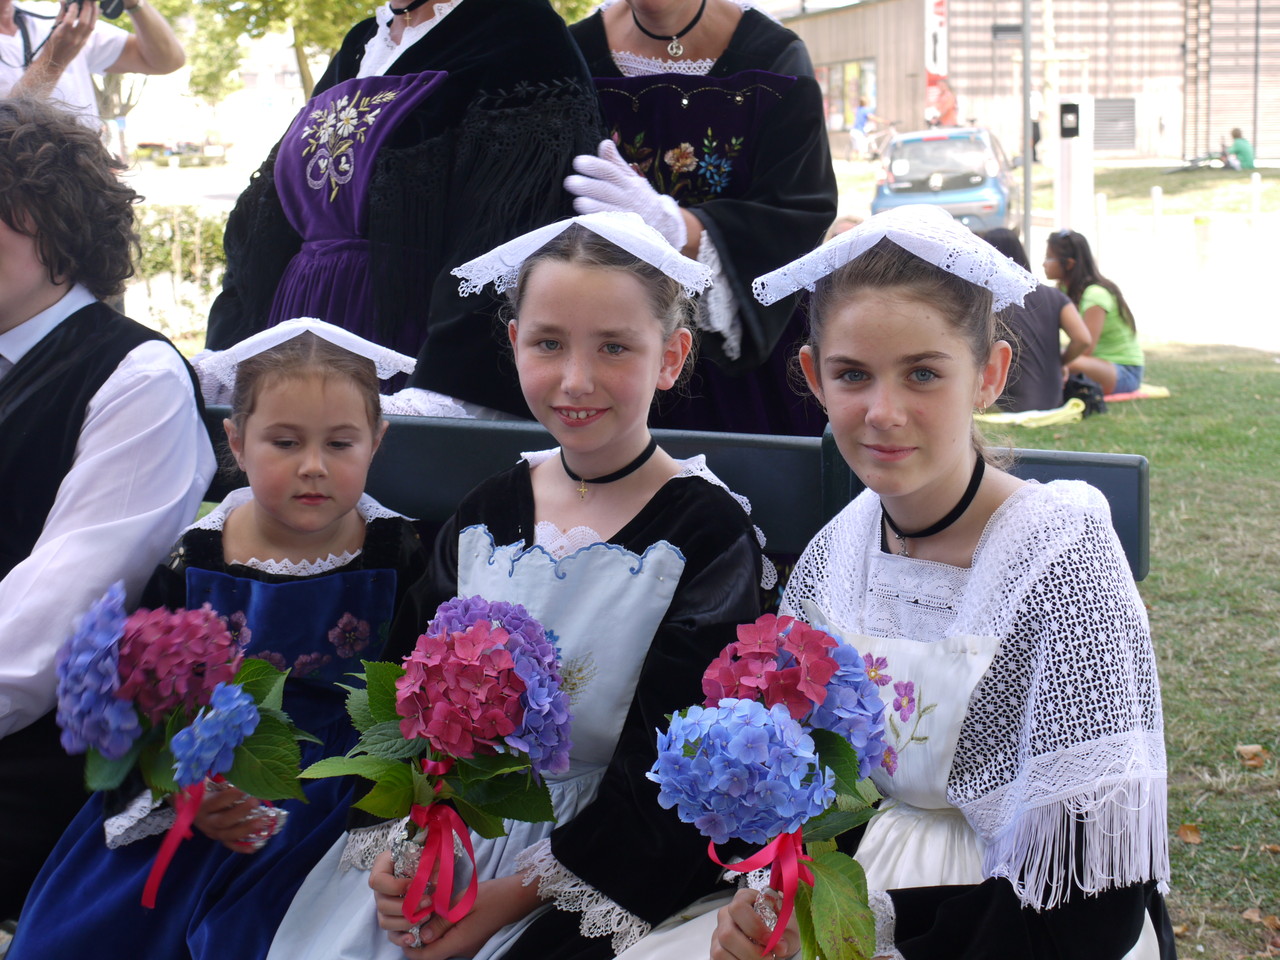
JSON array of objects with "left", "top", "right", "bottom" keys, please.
[{"left": 396, "top": 620, "right": 525, "bottom": 759}]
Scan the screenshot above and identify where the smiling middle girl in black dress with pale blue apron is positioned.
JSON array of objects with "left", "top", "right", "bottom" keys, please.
[{"left": 259, "top": 214, "right": 762, "bottom": 960}]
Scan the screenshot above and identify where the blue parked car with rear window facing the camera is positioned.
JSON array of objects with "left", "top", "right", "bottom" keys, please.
[{"left": 872, "top": 127, "right": 1021, "bottom": 230}]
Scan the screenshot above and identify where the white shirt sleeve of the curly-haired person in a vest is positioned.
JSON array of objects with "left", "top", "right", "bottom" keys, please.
[{"left": 0, "top": 343, "right": 215, "bottom": 736}]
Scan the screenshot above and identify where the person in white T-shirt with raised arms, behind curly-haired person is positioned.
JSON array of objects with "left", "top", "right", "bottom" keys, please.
[{"left": 0, "top": 0, "right": 187, "bottom": 129}]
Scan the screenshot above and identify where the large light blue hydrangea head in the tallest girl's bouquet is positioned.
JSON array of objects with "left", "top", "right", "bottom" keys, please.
[{"left": 646, "top": 698, "right": 836, "bottom": 844}]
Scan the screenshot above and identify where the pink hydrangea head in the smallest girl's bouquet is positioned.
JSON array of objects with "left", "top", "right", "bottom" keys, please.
[{"left": 116, "top": 603, "right": 243, "bottom": 723}]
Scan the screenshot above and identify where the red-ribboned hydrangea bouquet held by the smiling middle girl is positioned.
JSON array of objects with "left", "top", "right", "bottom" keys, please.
[{"left": 302, "top": 596, "right": 571, "bottom": 924}]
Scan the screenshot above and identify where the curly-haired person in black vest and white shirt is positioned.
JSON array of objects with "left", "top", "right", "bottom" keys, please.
[{"left": 0, "top": 96, "right": 214, "bottom": 920}]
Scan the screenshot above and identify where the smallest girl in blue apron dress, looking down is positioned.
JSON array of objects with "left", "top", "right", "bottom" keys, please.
[{"left": 9, "top": 320, "right": 426, "bottom": 960}]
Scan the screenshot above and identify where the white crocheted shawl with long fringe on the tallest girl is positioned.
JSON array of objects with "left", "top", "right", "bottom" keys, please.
[{"left": 782, "top": 480, "right": 1169, "bottom": 909}]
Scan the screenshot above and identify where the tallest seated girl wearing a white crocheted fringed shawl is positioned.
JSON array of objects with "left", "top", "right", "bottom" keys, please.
[{"left": 628, "top": 206, "right": 1174, "bottom": 960}]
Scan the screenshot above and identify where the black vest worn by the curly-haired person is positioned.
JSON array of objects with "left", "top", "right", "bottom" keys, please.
[{"left": 0, "top": 302, "right": 200, "bottom": 577}]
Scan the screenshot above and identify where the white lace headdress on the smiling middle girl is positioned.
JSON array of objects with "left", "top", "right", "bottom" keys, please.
[{"left": 449, "top": 212, "right": 712, "bottom": 297}]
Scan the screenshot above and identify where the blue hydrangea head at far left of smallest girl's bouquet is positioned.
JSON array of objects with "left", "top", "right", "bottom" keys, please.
[{"left": 58, "top": 581, "right": 142, "bottom": 760}]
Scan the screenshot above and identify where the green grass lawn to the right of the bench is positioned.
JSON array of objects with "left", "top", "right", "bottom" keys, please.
[{"left": 988, "top": 346, "right": 1280, "bottom": 960}]
